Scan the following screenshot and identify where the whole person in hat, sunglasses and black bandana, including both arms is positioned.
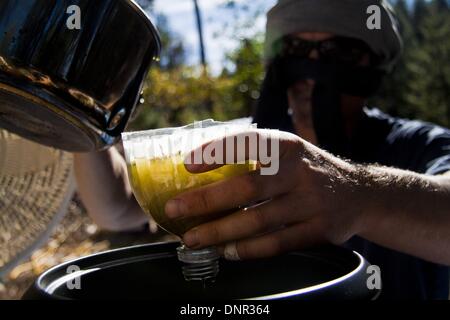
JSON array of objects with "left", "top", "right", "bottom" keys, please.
[{"left": 75, "top": 0, "right": 450, "bottom": 299}]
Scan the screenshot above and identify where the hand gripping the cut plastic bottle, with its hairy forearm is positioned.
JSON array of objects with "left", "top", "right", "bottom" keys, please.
[{"left": 166, "top": 130, "right": 450, "bottom": 265}]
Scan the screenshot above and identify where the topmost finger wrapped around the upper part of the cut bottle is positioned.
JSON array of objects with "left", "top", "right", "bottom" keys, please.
[{"left": 185, "top": 129, "right": 298, "bottom": 173}]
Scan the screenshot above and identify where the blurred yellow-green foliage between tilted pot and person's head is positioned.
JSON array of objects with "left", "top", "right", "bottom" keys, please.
[{"left": 130, "top": 29, "right": 264, "bottom": 130}]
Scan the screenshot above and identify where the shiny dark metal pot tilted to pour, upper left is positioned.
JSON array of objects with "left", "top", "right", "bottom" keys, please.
[{"left": 0, "top": 0, "right": 160, "bottom": 152}]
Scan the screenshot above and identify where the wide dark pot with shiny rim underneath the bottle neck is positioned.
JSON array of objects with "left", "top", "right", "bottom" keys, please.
[{"left": 24, "top": 242, "right": 380, "bottom": 301}]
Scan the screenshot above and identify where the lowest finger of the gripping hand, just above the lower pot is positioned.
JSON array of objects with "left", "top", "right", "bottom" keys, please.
[{"left": 219, "top": 221, "right": 326, "bottom": 260}]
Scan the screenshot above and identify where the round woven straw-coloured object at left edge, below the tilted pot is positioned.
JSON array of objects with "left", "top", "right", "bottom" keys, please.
[{"left": 0, "top": 129, "right": 75, "bottom": 277}]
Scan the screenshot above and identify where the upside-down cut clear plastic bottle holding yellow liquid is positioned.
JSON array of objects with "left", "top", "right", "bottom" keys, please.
[{"left": 122, "top": 120, "right": 256, "bottom": 280}]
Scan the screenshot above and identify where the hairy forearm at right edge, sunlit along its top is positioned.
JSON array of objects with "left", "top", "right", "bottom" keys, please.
[{"left": 359, "top": 167, "right": 450, "bottom": 265}]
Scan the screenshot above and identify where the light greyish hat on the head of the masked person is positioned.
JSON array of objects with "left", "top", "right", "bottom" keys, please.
[{"left": 264, "top": 0, "right": 403, "bottom": 71}]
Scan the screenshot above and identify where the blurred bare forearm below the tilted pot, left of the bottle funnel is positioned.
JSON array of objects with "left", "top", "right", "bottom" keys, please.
[{"left": 74, "top": 148, "right": 145, "bottom": 231}]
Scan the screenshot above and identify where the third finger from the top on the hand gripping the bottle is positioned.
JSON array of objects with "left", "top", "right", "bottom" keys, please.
[{"left": 183, "top": 196, "right": 301, "bottom": 249}]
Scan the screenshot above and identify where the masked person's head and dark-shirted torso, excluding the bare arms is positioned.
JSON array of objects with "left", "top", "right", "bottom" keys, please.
[{"left": 246, "top": 0, "right": 450, "bottom": 299}]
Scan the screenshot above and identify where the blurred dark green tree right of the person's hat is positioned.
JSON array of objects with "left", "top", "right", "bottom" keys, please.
[{"left": 371, "top": 0, "right": 450, "bottom": 126}]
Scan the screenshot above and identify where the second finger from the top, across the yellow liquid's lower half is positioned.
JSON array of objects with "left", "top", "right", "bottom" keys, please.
[{"left": 165, "top": 167, "right": 298, "bottom": 219}]
